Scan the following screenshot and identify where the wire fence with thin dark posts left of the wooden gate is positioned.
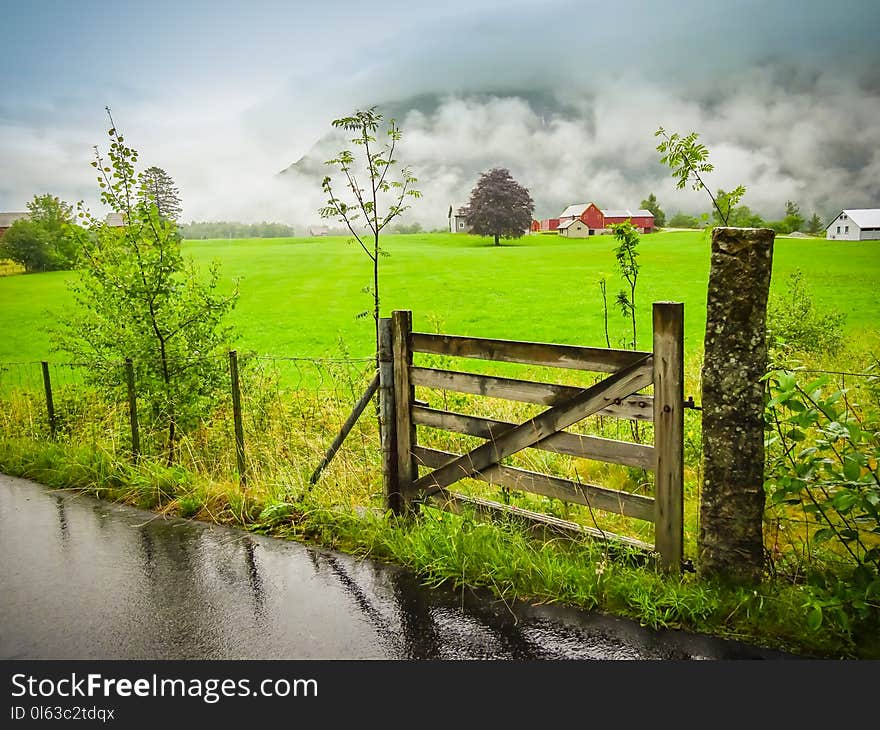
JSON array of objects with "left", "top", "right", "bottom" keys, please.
[{"left": 0, "top": 353, "right": 382, "bottom": 504}]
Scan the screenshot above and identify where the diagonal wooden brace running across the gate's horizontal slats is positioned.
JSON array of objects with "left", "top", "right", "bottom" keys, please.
[{"left": 408, "top": 355, "right": 654, "bottom": 497}]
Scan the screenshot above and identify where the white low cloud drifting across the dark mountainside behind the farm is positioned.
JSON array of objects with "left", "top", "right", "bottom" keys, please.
[{"left": 285, "top": 66, "right": 880, "bottom": 228}]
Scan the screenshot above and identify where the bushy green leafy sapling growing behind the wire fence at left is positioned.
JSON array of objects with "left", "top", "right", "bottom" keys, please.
[{"left": 54, "top": 108, "right": 238, "bottom": 464}]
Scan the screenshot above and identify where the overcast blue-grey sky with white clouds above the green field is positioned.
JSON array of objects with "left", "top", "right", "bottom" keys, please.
[{"left": 0, "top": 0, "right": 880, "bottom": 229}]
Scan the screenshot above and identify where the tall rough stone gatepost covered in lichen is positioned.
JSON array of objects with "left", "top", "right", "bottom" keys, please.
[{"left": 697, "top": 228, "right": 775, "bottom": 584}]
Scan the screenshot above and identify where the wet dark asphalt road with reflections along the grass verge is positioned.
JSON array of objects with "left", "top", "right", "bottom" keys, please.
[{"left": 0, "top": 475, "right": 785, "bottom": 659}]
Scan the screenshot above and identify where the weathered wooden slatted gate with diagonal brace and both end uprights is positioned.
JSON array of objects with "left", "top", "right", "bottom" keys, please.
[{"left": 379, "top": 302, "right": 685, "bottom": 571}]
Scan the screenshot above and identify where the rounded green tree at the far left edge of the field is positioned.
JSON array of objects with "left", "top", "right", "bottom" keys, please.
[{"left": 0, "top": 193, "right": 82, "bottom": 273}]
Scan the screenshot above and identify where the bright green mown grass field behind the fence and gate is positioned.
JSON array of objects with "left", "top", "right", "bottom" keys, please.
[{"left": 0, "top": 231, "right": 880, "bottom": 362}]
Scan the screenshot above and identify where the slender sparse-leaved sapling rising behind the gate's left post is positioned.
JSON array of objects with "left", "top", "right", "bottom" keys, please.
[{"left": 319, "top": 107, "right": 421, "bottom": 368}]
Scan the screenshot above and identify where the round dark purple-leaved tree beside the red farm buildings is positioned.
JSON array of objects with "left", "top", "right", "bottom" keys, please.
[{"left": 465, "top": 167, "right": 535, "bottom": 246}]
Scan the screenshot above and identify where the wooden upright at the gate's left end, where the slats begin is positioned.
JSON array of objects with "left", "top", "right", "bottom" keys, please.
[{"left": 391, "top": 309, "right": 419, "bottom": 512}]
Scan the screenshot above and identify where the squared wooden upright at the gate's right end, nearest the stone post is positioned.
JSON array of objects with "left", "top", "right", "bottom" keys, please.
[{"left": 653, "top": 302, "right": 684, "bottom": 573}]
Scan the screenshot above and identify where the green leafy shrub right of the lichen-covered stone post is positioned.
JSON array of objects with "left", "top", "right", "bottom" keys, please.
[{"left": 765, "top": 371, "right": 880, "bottom": 580}]
